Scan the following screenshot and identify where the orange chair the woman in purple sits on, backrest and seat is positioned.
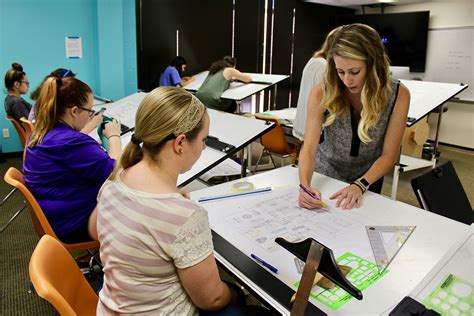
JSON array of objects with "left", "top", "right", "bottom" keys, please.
[{"left": 4, "top": 167, "right": 99, "bottom": 252}]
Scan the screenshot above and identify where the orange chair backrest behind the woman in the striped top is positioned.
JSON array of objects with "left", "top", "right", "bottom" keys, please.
[{"left": 29, "top": 235, "right": 98, "bottom": 315}]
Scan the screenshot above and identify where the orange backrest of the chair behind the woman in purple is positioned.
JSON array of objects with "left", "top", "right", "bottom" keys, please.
[{"left": 4, "top": 167, "right": 58, "bottom": 239}]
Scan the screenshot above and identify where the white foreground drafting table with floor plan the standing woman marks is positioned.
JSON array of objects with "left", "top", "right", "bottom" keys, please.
[{"left": 191, "top": 166, "right": 471, "bottom": 315}]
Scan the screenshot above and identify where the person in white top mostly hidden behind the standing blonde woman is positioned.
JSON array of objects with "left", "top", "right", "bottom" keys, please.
[{"left": 293, "top": 28, "right": 338, "bottom": 141}]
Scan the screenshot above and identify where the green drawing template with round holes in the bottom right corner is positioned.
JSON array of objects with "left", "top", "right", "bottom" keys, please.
[{"left": 422, "top": 274, "right": 474, "bottom": 315}]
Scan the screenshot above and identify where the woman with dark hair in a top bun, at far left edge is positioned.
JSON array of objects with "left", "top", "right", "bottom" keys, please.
[{"left": 4, "top": 63, "right": 32, "bottom": 122}]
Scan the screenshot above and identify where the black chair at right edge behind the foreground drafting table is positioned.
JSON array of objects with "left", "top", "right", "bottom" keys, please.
[{"left": 411, "top": 161, "right": 473, "bottom": 225}]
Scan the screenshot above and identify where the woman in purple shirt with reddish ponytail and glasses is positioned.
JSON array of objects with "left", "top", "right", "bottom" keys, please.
[{"left": 23, "top": 77, "right": 122, "bottom": 243}]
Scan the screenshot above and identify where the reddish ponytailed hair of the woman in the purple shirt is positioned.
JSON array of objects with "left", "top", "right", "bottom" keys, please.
[{"left": 28, "top": 77, "right": 92, "bottom": 148}]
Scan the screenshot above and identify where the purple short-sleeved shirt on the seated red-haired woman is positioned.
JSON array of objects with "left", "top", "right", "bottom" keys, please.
[{"left": 23, "top": 123, "right": 115, "bottom": 238}]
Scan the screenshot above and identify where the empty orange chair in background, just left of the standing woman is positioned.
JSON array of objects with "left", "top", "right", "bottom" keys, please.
[{"left": 254, "top": 115, "right": 296, "bottom": 173}]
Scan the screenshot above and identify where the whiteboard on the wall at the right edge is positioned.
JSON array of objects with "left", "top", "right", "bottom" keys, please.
[{"left": 424, "top": 26, "right": 474, "bottom": 101}]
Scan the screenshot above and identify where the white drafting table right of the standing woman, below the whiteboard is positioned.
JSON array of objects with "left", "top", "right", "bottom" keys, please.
[{"left": 391, "top": 80, "right": 468, "bottom": 199}]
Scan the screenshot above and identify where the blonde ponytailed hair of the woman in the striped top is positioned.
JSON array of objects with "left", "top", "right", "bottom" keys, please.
[{"left": 110, "top": 87, "right": 206, "bottom": 180}]
